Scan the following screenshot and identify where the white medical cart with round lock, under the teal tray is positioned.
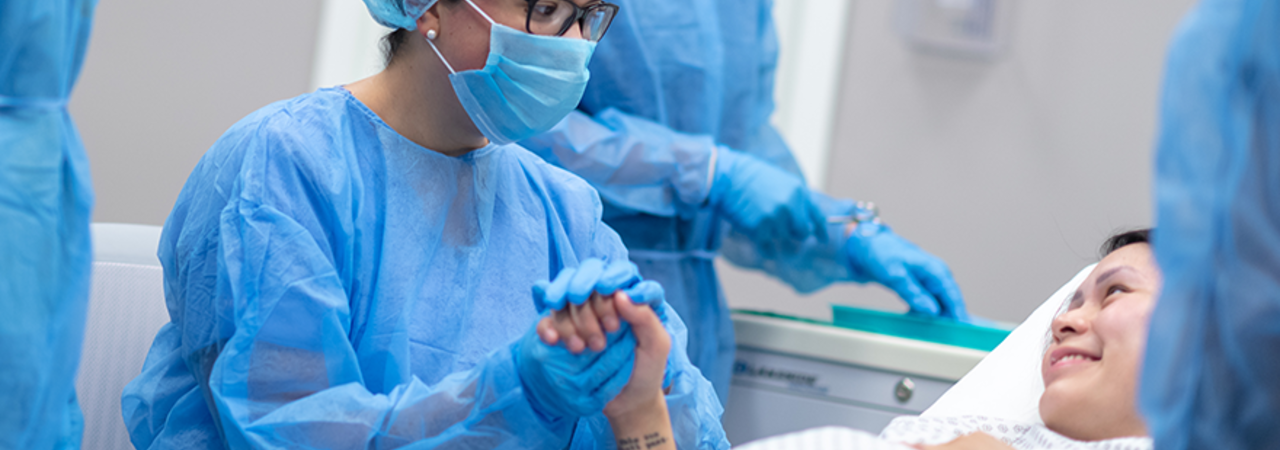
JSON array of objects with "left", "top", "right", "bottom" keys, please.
[{"left": 723, "top": 310, "right": 1007, "bottom": 445}]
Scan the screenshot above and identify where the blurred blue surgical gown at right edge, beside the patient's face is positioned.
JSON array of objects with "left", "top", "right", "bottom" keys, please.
[{"left": 1139, "top": 0, "right": 1280, "bottom": 450}]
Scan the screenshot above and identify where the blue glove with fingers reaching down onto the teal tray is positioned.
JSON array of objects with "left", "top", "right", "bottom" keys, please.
[{"left": 845, "top": 222, "right": 969, "bottom": 321}]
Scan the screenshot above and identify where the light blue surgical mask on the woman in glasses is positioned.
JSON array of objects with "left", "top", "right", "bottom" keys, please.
[{"left": 426, "top": 0, "right": 595, "bottom": 144}]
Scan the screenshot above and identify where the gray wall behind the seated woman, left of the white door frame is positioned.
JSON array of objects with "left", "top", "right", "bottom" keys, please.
[{"left": 70, "top": 0, "right": 320, "bottom": 225}]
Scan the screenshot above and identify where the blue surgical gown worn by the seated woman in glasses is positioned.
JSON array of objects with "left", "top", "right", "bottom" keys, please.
[{"left": 122, "top": 88, "right": 727, "bottom": 449}]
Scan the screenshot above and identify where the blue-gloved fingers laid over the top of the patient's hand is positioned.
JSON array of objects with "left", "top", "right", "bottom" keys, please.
[{"left": 534, "top": 258, "right": 666, "bottom": 313}]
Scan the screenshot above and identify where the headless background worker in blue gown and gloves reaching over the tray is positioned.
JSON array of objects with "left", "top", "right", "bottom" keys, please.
[{"left": 521, "top": 0, "right": 968, "bottom": 401}]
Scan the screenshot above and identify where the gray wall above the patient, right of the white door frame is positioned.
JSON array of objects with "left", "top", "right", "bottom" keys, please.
[{"left": 721, "top": 0, "right": 1193, "bottom": 321}]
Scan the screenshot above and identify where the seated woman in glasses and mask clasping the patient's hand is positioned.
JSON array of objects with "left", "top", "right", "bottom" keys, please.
[{"left": 122, "top": 0, "right": 727, "bottom": 449}]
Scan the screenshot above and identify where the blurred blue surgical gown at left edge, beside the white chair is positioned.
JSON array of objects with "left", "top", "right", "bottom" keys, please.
[{"left": 0, "top": 0, "right": 97, "bottom": 449}]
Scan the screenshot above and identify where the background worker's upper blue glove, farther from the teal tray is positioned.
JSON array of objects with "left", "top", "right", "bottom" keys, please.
[{"left": 708, "top": 147, "right": 827, "bottom": 243}]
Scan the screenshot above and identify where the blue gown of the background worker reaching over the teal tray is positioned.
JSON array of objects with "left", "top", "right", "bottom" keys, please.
[{"left": 521, "top": 0, "right": 865, "bottom": 399}]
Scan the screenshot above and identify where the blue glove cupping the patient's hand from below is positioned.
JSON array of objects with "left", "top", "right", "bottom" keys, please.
[{"left": 516, "top": 322, "right": 636, "bottom": 421}]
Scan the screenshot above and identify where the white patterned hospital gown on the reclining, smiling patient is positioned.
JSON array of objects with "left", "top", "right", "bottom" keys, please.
[{"left": 740, "top": 415, "right": 1152, "bottom": 450}]
